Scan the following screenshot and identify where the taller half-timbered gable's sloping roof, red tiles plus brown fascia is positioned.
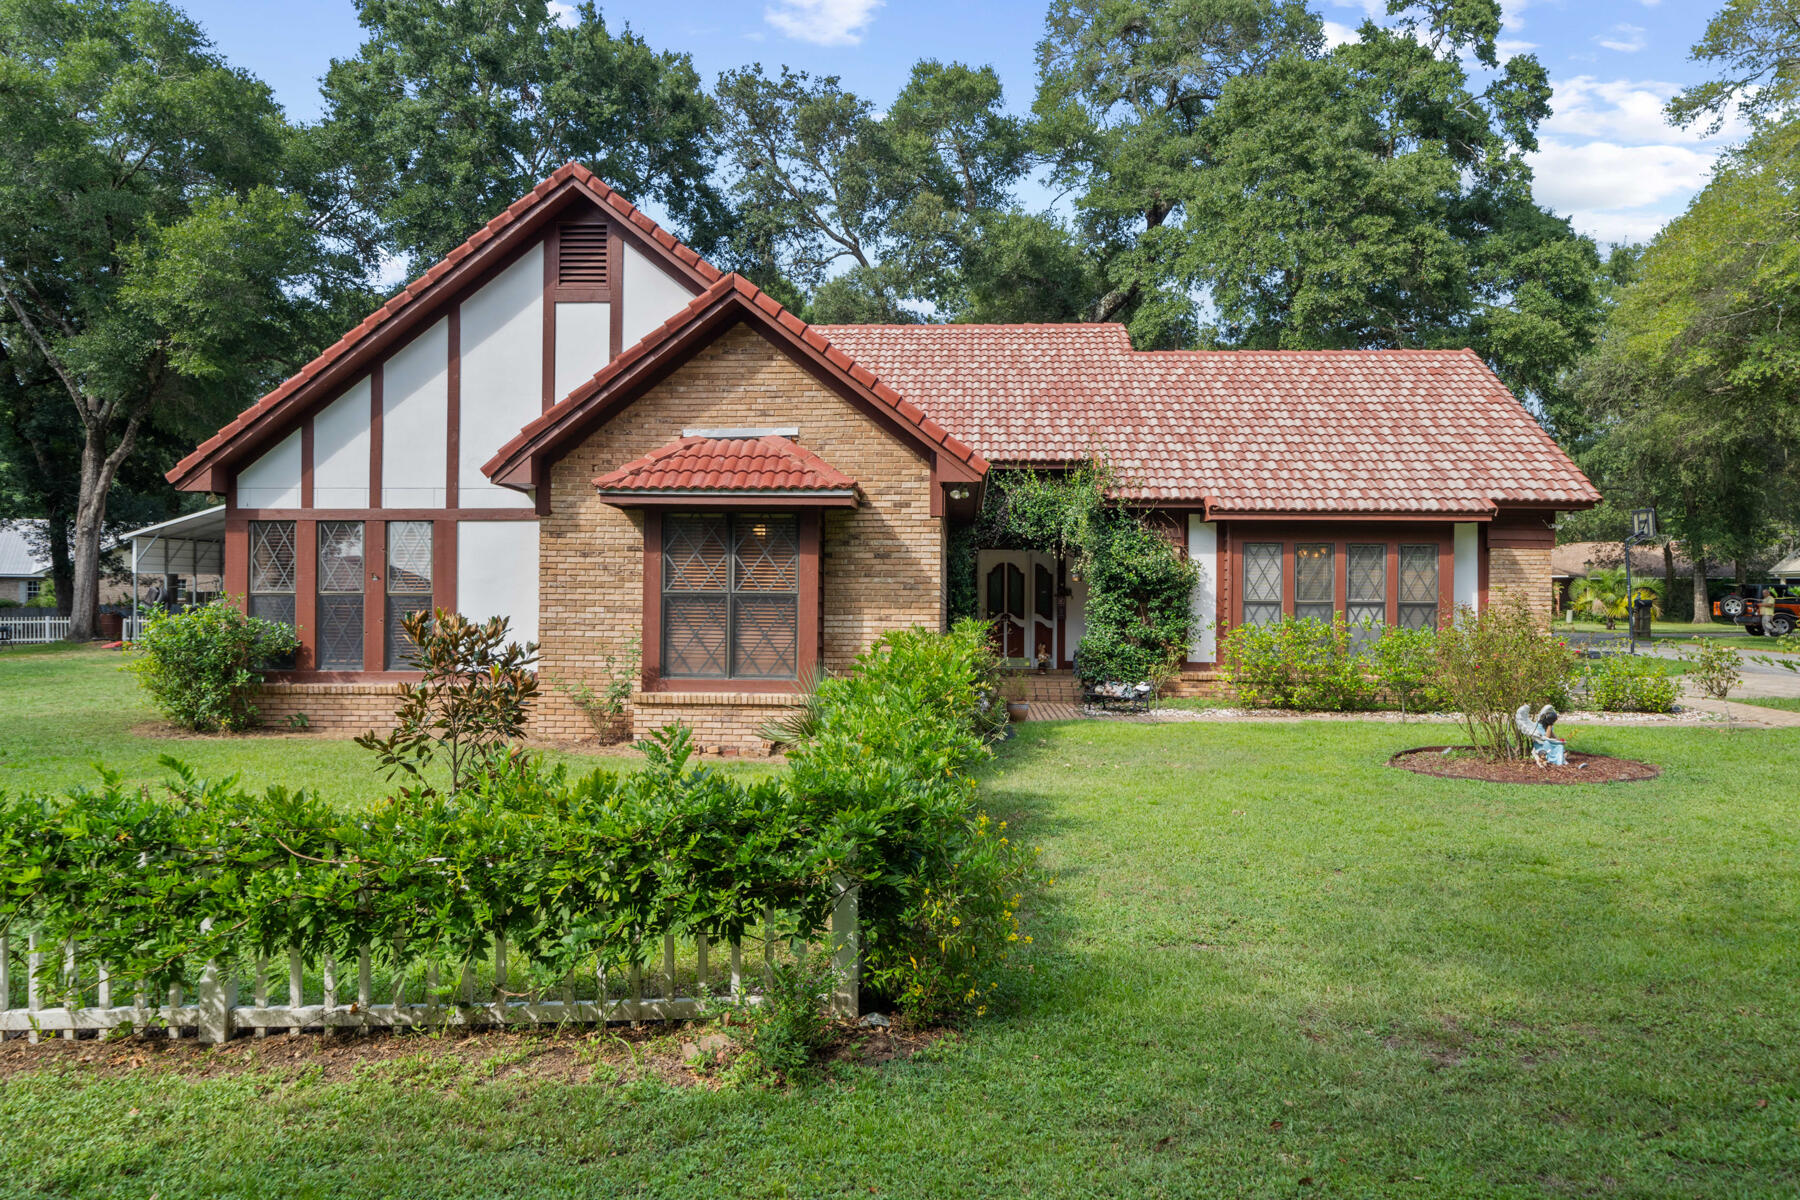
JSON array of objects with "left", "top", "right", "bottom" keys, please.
[{"left": 167, "top": 162, "right": 722, "bottom": 491}]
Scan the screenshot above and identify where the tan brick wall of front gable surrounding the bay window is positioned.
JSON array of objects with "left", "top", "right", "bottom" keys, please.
[{"left": 533, "top": 326, "right": 943, "bottom": 748}]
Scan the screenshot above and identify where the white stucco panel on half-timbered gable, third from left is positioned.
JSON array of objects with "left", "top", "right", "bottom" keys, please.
[{"left": 382, "top": 318, "right": 450, "bottom": 509}]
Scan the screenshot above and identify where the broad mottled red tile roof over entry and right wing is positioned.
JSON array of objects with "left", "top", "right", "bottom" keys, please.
[{"left": 819, "top": 324, "right": 1600, "bottom": 513}]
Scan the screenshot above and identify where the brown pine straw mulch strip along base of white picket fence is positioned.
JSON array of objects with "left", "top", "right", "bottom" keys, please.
[{"left": 0, "top": 1022, "right": 945, "bottom": 1087}]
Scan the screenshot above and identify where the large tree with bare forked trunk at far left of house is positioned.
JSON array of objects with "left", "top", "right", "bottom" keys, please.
[{"left": 0, "top": 0, "right": 361, "bottom": 639}]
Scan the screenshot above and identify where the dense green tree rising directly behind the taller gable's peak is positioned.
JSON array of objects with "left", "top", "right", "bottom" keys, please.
[{"left": 324, "top": 0, "right": 729, "bottom": 270}]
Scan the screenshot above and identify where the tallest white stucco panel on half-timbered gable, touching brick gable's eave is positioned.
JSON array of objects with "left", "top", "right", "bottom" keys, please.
[{"left": 457, "top": 245, "right": 544, "bottom": 509}]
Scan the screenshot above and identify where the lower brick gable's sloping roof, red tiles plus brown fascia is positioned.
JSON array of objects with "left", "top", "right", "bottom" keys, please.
[{"left": 481, "top": 273, "right": 988, "bottom": 488}]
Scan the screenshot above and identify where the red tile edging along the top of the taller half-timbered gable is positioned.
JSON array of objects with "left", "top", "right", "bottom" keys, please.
[{"left": 166, "top": 162, "right": 722, "bottom": 491}]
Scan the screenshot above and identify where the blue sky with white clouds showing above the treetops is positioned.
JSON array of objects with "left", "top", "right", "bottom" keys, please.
[{"left": 176, "top": 0, "right": 1730, "bottom": 241}]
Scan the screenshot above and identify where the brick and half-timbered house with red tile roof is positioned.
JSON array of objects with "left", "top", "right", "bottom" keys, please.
[{"left": 169, "top": 164, "right": 1598, "bottom": 748}]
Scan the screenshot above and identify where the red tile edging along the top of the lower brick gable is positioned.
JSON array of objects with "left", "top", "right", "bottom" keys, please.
[{"left": 481, "top": 273, "right": 988, "bottom": 486}]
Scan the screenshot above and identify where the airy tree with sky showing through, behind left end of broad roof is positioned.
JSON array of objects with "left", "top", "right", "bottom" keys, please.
[{"left": 718, "top": 59, "right": 1087, "bottom": 322}]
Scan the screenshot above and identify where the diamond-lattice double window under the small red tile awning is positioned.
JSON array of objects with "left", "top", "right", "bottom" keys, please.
[{"left": 662, "top": 513, "right": 799, "bottom": 680}]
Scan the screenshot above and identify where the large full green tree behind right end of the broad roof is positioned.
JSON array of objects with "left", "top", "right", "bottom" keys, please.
[{"left": 1166, "top": 0, "right": 1602, "bottom": 401}]
